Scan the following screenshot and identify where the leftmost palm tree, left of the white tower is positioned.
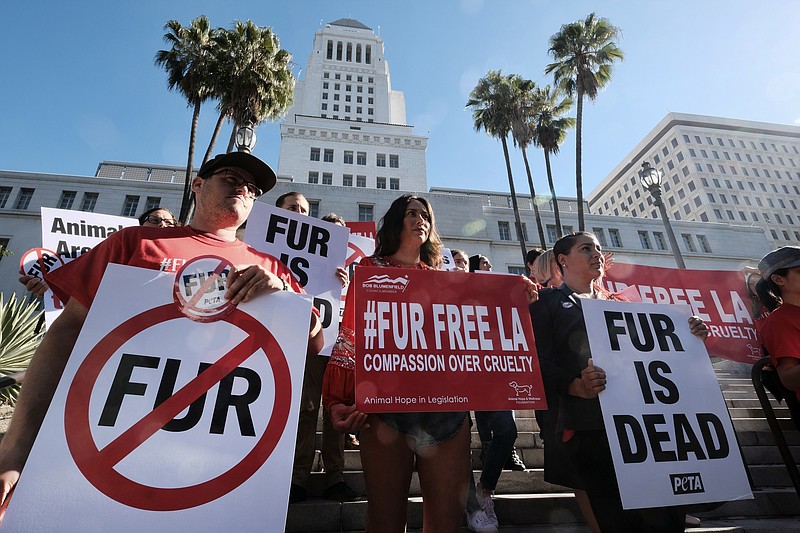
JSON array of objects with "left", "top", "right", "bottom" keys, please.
[{"left": 155, "top": 15, "right": 217, "bottom": 224}]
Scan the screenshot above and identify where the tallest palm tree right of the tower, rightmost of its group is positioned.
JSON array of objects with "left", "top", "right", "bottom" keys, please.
[{"left": 545, "top": 13, "right": 623, "bottom": 231}]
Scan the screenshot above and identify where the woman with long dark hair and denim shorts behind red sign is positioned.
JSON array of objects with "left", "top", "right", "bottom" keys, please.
[{"left": 323, "top": 194, "right": 470, "bottom": 533}]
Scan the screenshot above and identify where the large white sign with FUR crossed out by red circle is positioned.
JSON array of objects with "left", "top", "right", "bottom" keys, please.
[{"left": 3, "top": 264, "right": 311, "bottom": 533}]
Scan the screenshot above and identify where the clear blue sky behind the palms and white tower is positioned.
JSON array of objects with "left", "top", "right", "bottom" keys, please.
[{"left": 0, "top": 0, "right": 800, "bottom": 196}]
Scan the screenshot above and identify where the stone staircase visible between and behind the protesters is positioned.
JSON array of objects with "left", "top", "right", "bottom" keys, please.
[{"left": 286, "top": 361, "right": 800, "bottom": 533}]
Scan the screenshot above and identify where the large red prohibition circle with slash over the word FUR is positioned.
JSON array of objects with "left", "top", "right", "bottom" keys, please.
[{"left": 64, "top": 304, "right": 292, "bottom": 511}]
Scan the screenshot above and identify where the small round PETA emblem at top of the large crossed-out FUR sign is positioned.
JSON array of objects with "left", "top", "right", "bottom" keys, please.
[{"left": 172, "top": 255, "right": 234, "bottom": 322}]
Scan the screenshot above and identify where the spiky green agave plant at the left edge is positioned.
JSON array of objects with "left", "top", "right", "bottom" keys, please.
[{"left": 0, "top": 293, "right": 43, "bottom": 405}]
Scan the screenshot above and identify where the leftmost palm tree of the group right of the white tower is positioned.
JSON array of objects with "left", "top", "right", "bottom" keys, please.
[{"left": 466, "top": 70, "right": 527, "bottom": 264}]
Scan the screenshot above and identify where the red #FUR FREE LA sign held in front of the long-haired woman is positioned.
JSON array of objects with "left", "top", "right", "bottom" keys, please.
[{"left": 353, "top": 267, "right": 546, "bottom": 412}]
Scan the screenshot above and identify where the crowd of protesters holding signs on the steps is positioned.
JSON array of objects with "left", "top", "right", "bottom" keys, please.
[{"left": 0, "top": 154, "right": 800, "bottom": 533}]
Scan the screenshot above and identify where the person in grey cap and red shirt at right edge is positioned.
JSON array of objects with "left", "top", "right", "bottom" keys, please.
[{"left": 756, "top": 246, "right": 800, "bottom": 399}]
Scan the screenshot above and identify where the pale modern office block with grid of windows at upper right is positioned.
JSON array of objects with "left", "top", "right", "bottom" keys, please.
[{"left": 589, "top": 113, "right": 800, "bottom": 248}]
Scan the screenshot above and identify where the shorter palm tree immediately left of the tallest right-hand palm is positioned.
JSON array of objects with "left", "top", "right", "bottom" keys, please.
[{"left": 531, "top": 85, "right": 575, "bottom": 238}]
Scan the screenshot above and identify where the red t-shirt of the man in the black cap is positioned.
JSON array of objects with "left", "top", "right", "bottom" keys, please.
[{"left": 46, "top": 226, "right": 305, "bottom": 309}]
